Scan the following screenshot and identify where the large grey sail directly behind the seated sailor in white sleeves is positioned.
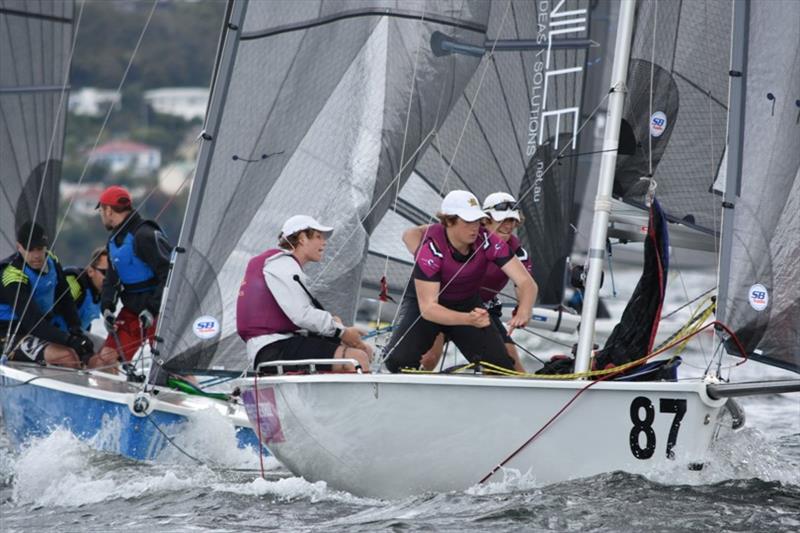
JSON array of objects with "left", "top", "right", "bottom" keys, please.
[{"left": 157, "top": 0, "right": 489, "bottom": 370}]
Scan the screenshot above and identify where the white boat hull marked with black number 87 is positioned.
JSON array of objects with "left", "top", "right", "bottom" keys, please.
[{"left": 240, "top": 374, "right": 725, "bottom": 498}]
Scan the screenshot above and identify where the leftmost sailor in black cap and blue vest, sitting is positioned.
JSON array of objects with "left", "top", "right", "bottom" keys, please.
[{"left": 0, "top": 222, "right": 94, "bottom": 368}]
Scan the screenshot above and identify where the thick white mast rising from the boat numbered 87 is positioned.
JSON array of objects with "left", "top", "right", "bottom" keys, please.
[{"left": 575, "top": 0, "right": 636, "bottom": 372}]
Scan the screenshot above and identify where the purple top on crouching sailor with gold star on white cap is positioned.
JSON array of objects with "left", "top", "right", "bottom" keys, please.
[{"left": 414, "top": 224, "right": 514, "bottom": 302}]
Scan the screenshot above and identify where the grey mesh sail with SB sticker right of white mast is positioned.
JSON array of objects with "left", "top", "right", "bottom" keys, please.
[{"left": 614, "top": 0, "right": 731, "bottom": 235}]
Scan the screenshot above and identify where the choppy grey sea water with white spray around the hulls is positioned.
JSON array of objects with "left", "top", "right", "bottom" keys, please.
[{"left": 0, "top": 268, "right": 800, "bottom": 533}]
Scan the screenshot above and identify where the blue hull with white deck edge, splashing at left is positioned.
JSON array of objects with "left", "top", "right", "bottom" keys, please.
[{"left": 0, "top": 363, "right": 258, "bottom": 460}]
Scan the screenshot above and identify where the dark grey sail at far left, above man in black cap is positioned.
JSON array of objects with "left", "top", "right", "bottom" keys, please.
[{"left": 0, "top": 0, "right": 74, "bottom": 258}]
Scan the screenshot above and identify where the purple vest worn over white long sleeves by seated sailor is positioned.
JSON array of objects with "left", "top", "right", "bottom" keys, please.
[{"left": 236, "top": 248, "right": 300, "bottom": 342}]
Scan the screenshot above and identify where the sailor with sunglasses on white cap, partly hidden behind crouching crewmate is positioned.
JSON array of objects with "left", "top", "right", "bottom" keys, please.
[{"left": 403, "top": 192, "right": 539, "bottom": 372}]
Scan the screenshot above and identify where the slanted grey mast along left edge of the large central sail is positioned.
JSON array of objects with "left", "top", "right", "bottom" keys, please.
[{"left": 149, "top": 0, "right": 248, "bottom": 383}]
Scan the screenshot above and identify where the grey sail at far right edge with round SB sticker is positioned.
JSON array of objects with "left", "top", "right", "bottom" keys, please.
[{"left": 720, "top": 0, "right": 800, "bottom": 372}]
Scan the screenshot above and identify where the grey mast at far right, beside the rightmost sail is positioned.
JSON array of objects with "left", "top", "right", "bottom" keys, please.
[{"left": 717, "top": 0, "right": 750, "bottom": 323}]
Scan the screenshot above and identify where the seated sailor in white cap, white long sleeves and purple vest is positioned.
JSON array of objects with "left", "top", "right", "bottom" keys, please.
[{"left": 236, "top": 215, "right": 372, "bottom": 372}]
